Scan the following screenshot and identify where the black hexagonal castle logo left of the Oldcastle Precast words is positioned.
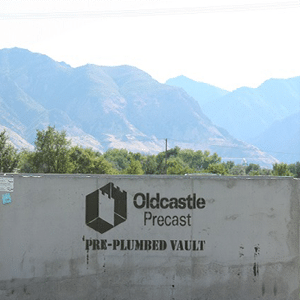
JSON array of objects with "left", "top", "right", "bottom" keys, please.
[{"left": 85, "top": 182, "right": 127, "bottom": 233}]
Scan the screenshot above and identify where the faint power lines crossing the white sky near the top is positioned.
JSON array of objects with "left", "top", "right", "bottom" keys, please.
[{"left": 0, "top": 1, "right": 300, "bottom": 20}]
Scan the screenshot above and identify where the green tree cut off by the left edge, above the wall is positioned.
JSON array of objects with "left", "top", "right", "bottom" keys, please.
[{"left": 0, "top": 130, "right": 19, "bottom": 173}]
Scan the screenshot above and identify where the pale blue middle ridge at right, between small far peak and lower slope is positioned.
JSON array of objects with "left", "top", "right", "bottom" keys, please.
[{"left": 202, "top": 77, "right": 300, "bottom": 142}]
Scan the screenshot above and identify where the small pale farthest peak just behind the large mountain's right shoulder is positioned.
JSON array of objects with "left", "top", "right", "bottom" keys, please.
[{"left": 166, "top": 75, "right": 229, "bottom": 107}]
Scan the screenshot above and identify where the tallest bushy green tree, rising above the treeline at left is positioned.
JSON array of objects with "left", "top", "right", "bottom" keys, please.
[{"left": 33, "top": 126, "right": 71, "bottom": 173}]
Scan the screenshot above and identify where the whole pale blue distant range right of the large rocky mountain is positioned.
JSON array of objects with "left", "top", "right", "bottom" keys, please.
[{"left": 167, "top": 76, "right": 300, "bottom": 162}]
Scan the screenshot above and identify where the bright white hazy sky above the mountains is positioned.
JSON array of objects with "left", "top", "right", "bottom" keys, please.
[{"left": 0, "top": 0, "right": 300, "bottom": 90}]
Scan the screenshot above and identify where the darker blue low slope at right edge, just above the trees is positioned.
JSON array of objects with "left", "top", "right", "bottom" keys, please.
[{"left": 253, "top": 112, "right": 300, "bottom": 163}]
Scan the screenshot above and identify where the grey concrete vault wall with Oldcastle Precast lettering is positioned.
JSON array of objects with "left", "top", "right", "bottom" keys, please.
[{"left": 0, "top": 174, "right": 300, "bottom": 300}]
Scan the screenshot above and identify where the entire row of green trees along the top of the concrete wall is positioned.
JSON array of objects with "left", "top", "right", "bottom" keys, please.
[{"left": 0, "top": 126, "right": 300, "bottom": 178}]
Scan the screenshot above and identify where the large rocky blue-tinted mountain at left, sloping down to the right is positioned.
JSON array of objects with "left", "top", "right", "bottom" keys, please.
[{"left": 0, "top": 48, "right": 276, "bottom": 165}]
